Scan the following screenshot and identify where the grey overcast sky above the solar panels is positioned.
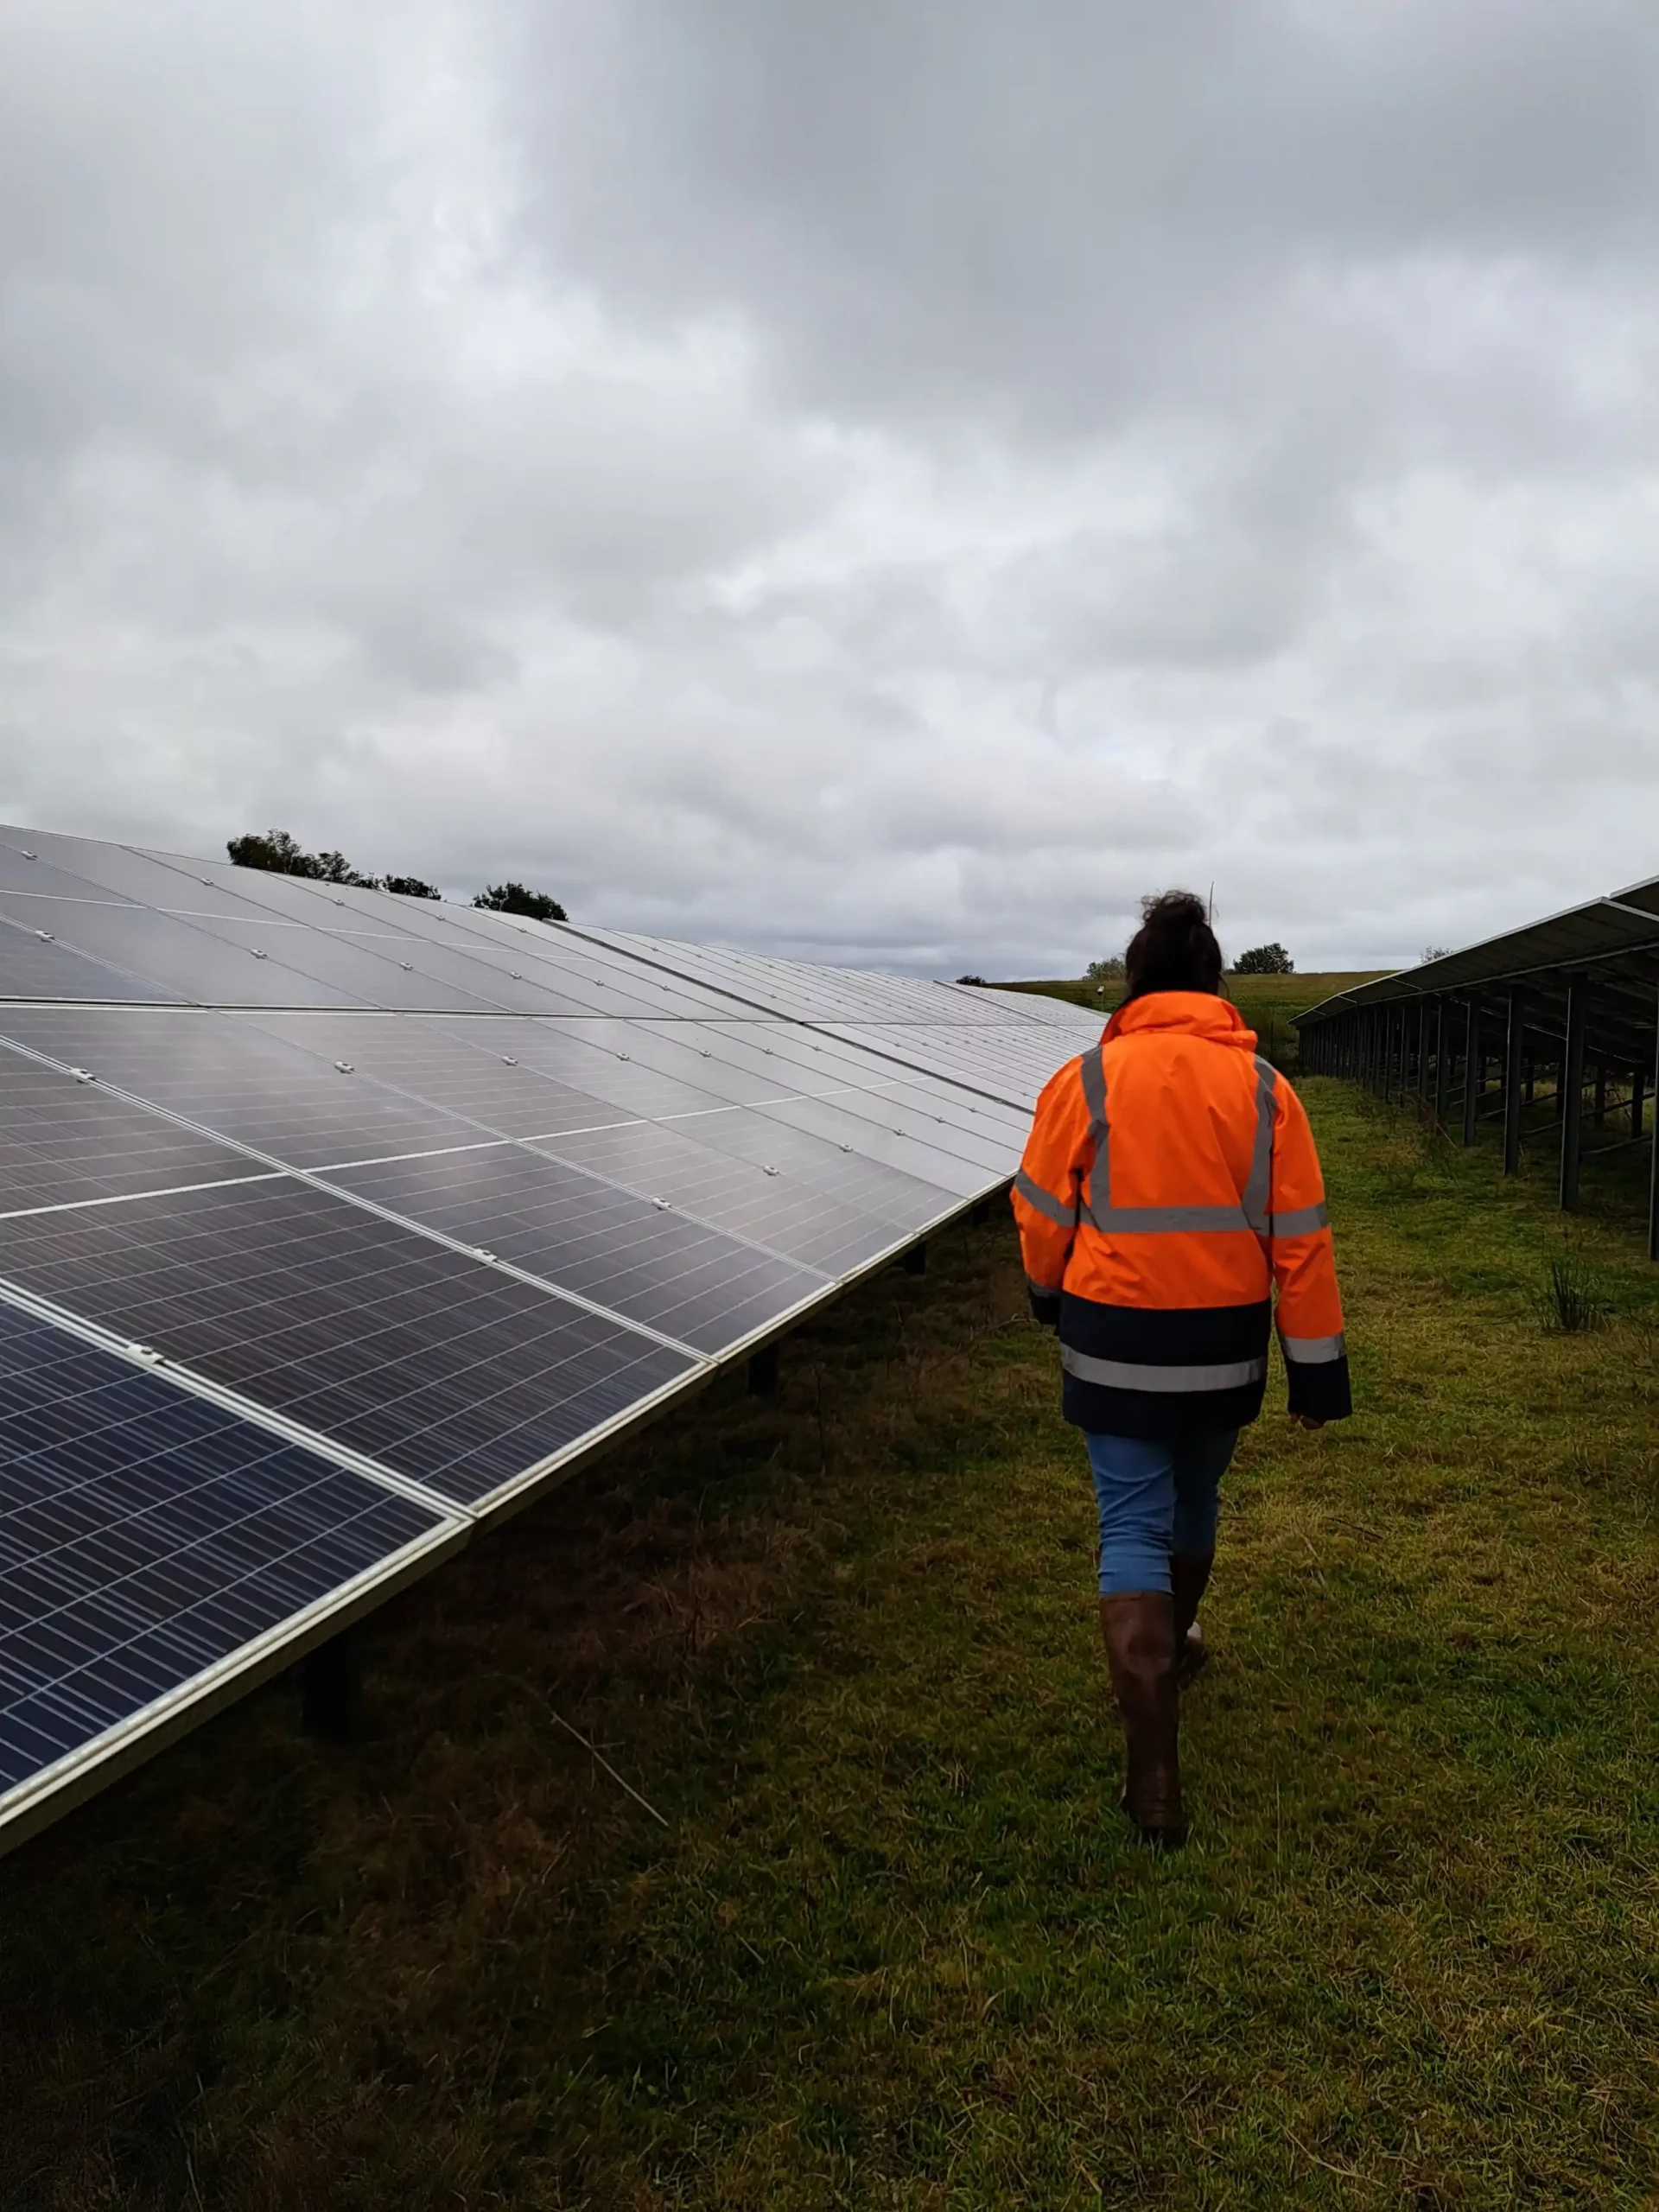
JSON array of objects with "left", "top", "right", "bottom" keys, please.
[{"left": 0, "top": 0, "right": 1659, "bottom": 976}]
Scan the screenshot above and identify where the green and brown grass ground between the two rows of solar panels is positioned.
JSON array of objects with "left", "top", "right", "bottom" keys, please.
[{"left": 0, "top": 1082, "right": 1659, "bottom": 2212}]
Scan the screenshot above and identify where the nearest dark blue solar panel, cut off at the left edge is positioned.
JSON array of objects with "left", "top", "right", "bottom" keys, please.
[{"left": 0, "top": 1303, "right": 460, "bottom": 1838}]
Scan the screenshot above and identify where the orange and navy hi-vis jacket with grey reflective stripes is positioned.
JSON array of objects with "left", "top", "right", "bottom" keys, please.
[{"left": 1013, "top": 991, "right": 1354, "bottom": 1435}]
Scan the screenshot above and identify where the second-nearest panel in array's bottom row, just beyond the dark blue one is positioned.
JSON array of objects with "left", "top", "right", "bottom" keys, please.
[{"left": 0, "top": 1179, "right": 695, "bottom": 1504}]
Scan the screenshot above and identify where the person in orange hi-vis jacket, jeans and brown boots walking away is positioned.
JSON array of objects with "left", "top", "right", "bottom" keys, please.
[{"left": 1013, "top": 892, "right": 1354, "bottom": 1845}]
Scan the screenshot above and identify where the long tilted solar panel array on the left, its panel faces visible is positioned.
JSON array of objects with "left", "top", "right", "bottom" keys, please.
[{"left": 0, "top": 830, "right": 1097, "bottom": 1847}]
